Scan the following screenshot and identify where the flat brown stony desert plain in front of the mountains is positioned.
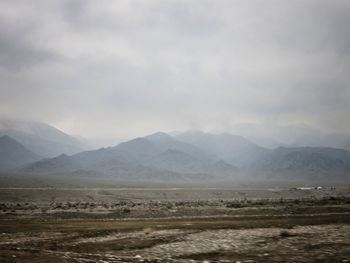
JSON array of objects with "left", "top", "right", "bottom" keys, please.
[{"left": 0, "top": 184, "right": 350, "bottom": 263}]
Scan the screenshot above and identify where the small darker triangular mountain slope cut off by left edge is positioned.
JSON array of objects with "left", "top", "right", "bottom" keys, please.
[{"left": 0, "top": 135, "right": 41, "bottom": 170}]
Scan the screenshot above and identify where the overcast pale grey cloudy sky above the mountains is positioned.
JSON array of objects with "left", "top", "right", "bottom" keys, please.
[{"left": 0, "top": 0, "right": 350, "bottom": 142}]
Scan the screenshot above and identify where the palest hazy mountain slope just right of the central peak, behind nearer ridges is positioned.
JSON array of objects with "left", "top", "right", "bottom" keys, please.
[{"left": 176, "top": 132, "right": 268, "bottom": 167}]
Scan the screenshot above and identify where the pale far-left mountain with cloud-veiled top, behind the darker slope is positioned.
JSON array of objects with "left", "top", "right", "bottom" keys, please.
[{"left": 0, "top": 119, "right": 88, "bottom": 157}]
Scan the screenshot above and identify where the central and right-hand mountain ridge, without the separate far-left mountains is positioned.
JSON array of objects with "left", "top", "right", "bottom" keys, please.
[{"left": 21, "top": 133, "right": 350, "bottom": 181}]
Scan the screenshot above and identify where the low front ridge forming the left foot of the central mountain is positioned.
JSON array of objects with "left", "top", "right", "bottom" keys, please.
[{"left": 20, "top": 148, "right": 189, "bottom": 181}]
